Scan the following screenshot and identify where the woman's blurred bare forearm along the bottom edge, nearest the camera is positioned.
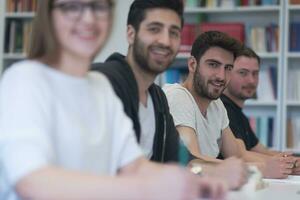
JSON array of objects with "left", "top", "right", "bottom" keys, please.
[{"left": 16, "top": 167, "right": 142, "bottom": 200}]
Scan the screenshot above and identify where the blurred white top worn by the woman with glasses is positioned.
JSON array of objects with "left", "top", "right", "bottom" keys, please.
[{"left": 0, "top": 60, "right": 142, "bottom": 200}]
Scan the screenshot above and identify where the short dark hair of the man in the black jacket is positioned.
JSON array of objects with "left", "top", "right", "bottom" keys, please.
[{"left": 127, "top": 0, "right": 184, "bottom": 31}]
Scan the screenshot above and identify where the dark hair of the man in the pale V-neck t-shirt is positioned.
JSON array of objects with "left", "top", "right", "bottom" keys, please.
[{"left": 191, "top": 31, "right": 242, "bottom": 62}]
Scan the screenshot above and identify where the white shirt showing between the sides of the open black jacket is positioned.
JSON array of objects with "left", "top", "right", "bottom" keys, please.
[{"left": 139, "top": 94, "right": 155, "bottom": 159}]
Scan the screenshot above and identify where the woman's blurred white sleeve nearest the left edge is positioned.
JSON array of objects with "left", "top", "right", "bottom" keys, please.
[{"left": 0, "top": 64, "right": 52, "bottom": 186}]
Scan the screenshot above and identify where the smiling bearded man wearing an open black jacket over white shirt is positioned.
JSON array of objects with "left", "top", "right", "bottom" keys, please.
[{"left": 93, "top": 0, "right": 183, "bottom": 162}]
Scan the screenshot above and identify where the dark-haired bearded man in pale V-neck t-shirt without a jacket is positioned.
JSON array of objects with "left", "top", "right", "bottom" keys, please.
[{"left": 164, "top": 31, "right": 288, "bottom": 175}]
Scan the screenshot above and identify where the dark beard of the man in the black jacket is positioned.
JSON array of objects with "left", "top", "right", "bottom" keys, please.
[{"left": 132, "top": 37, "right": 176, "bottom": 76}]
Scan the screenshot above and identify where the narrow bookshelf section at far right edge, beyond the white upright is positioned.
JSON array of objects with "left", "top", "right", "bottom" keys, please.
[{"left": 281, "top": 0, "right": 300, "bottom": 152}]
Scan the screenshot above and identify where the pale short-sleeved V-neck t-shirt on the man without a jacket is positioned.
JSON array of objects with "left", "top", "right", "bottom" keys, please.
[{"left": 163, "top": 84, "right": 229, "bottom": 158}]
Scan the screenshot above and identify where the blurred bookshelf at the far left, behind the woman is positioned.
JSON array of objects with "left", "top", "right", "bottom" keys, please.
[{"left": 0, "top": 0, "right": 37, "bottom": 72}]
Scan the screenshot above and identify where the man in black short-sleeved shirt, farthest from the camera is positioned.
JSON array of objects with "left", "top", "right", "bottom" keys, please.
[{"left": 221, "top": 47, "right": 300, "bottom": 178}]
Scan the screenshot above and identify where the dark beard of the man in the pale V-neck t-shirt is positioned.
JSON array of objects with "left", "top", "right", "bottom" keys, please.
[{"left": 193, "top": 66, "right": 225, "bottom": 100}]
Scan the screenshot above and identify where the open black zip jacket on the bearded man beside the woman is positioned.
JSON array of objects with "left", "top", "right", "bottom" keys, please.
[{"left": 92, "top": 53, "right": 180, "bottom": 162}]
